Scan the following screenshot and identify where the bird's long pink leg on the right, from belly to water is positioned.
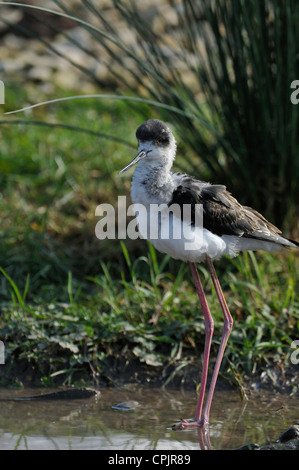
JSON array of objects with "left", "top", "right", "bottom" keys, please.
[{"left": 201, "top": 256, "right": 233, "bottom": 424}]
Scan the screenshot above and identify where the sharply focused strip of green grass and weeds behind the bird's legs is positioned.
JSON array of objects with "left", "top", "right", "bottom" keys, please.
[{"left": 0, "top": 245, "right": 299, "bottom": 385}]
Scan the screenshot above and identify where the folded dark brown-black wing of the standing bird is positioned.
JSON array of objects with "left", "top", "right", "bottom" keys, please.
[{"left": 169, "top": 174, "right": 281, "bottom": 239}]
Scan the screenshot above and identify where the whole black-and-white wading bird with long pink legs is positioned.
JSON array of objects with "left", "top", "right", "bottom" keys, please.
[{"left": 120, "top": 119, "right": 299, "bottom": 429}]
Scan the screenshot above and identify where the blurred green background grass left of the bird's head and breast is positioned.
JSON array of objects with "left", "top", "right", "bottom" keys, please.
[{"left": 0, "top": 90, "right": 147, "bottom": 299}]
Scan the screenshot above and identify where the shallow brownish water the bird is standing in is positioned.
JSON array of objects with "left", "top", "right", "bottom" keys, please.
[{"left": 0, "top": 389, "right": 299, "bottom": 450}]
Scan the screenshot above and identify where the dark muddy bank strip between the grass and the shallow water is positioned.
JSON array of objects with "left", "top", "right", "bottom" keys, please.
[{"left": 0, "top": 358, "right": 299, "bottom": 399}]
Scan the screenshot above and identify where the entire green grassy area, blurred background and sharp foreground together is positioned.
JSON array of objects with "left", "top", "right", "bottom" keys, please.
[{"left": 0, "top": 85, "right": 299, "bottom": 386}]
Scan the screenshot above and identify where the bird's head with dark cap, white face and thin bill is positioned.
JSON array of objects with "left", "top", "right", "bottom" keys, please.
[{"left": 120, "top": 119, "right": 176, "bottom": 173}]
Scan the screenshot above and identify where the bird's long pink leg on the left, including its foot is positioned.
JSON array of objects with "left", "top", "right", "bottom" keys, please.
[{"left": 173, "top": 262, "right": 214, "bottom": 429}]
